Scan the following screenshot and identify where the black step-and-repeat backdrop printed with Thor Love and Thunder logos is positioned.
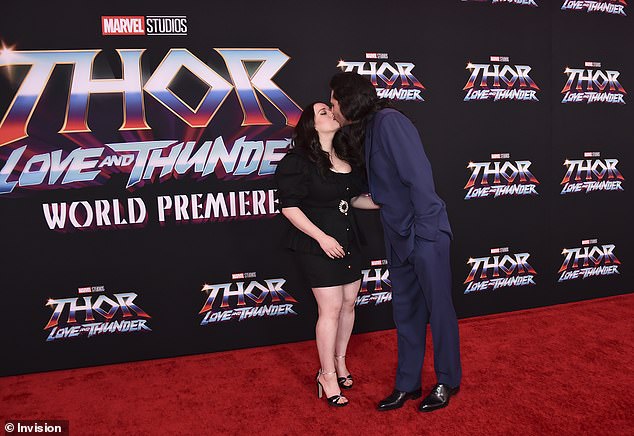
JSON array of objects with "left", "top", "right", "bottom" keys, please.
[{"left": 0, "top": 0, "right": 634, "bottom": 375}]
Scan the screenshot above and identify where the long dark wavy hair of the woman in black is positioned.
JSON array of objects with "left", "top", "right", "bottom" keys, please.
[{"left": 291, "top": 101, "right": 362, "bottom": 177}]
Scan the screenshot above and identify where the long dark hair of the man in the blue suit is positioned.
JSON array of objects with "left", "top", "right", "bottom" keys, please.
[{"left": 330, "top": 72, "right": 392, "bottom": 150}]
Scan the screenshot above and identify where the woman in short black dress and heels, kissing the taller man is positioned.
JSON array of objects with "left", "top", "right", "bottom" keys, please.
[{"left": 275, "top": 102, "right": 378, "bottom": 407}]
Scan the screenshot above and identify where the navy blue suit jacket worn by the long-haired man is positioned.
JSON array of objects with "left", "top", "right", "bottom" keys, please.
[{"left": 364, "top": 109, "right": 451, "bottom": 263}]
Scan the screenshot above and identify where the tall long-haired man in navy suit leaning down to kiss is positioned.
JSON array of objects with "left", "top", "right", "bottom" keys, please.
[{"left": 330, "top": 73, "right": 462, "bottom": 412}]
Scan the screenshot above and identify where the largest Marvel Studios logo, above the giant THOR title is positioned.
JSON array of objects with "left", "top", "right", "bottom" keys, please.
[{"left": 101, "top": 15, "right": 187, "bottom": 36}]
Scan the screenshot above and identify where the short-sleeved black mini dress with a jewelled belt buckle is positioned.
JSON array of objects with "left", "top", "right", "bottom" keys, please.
[{"left": 275, "top": 150, "right": 367, "bottom": 288}]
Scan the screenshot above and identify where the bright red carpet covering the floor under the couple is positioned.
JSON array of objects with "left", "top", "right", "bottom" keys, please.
[{"left": 0, "top": 294, "right": 634, "bottom": 436}]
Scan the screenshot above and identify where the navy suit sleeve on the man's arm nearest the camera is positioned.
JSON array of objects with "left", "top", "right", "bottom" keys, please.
[{"left": 377, "top": 112, "right": 445, "bottom": 240}]
